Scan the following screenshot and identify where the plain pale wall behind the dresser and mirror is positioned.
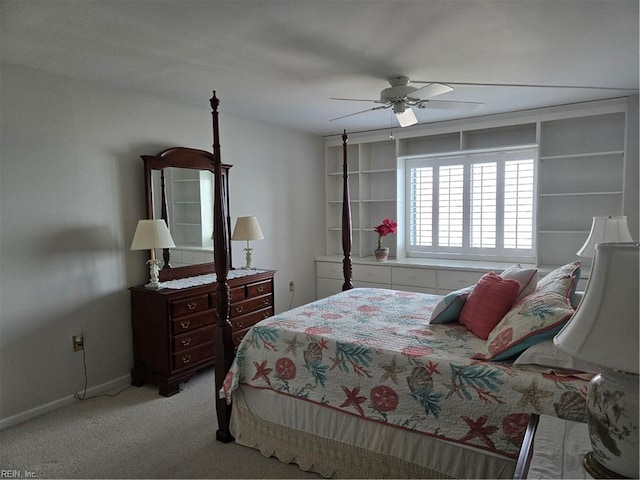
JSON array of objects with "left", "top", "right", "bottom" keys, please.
[{"left": 0, "top": 63, "right": 324, "bottom": 426}]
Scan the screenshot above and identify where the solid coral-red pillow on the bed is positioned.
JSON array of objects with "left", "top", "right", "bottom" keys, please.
[{"left": 459, "top": 272, "right": 520, "bottom": 340}]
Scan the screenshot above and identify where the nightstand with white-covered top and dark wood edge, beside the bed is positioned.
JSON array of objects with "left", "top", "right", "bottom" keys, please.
[{"left": 514, "top": 414, "right": 593, "bottom": 479}]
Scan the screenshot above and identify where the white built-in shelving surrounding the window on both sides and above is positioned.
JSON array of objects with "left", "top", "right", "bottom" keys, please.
[{"left": 323, "top": 98, "right": 638, "bottom": 298}]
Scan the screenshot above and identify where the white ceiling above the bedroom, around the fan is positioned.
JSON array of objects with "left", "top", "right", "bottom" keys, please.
[{"left": 0, "top": 0, "right": 639, "bottom": 135}]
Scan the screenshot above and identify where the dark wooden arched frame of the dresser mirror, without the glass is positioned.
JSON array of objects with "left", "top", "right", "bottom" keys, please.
[{"left": 141, "top": 147, "right": 232, "bottom": 281}]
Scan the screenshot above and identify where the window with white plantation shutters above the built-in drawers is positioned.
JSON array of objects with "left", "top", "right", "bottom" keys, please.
[{"left": 406, "top": 146, "right": 538, "bottom": 261}]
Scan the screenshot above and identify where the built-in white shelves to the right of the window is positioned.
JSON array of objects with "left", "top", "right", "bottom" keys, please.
[{"left": 538, "top": 111, "right": 626, "bottom": 265}]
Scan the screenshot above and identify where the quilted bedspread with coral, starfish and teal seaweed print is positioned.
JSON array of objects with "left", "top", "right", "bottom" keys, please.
[{"left": 223, "top": 288, "right": 587, "bottom": 458}]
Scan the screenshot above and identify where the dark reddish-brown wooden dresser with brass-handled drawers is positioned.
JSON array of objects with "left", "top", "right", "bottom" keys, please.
[{"left": 130, "top": 270, "right": 275, "bottom": 396}]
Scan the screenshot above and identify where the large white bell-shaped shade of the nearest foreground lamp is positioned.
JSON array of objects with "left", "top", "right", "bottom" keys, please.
[{"left": 553, "top": 243, "right": 640, "bottom": 374}]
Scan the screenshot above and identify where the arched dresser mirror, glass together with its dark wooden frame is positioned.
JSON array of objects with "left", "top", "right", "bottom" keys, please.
[{"left": 142, "top": 147, "right": 232, "bottom": 281}]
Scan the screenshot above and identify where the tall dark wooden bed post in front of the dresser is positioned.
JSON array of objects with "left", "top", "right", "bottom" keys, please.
[{"left": 210, "top": 90, "right": 235, "bottom": 443}]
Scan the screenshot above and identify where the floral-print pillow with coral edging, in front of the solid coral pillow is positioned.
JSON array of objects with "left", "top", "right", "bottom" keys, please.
[{"left": 472, "top": 290, "right": 573, "bottom": 361}]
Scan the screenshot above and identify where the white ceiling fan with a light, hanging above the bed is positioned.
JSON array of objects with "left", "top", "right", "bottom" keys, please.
[{"left": 330, "top": 75, "right": 628, "bottom": 127}]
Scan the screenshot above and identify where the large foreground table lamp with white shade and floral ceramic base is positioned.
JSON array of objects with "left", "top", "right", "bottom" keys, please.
[{"left": 553, "top": 244, "right": 640, "bottom": 478}]
